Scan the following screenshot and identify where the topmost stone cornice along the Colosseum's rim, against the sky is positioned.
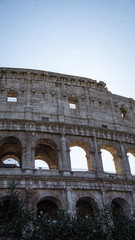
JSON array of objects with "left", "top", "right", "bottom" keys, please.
[{"left": 0, "top": 68, "right": 107, "bottom": 91}]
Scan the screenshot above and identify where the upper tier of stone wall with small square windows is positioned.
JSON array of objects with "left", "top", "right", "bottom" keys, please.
[{"left": 0, "top": 68, "right": 135, "bottom": 134}]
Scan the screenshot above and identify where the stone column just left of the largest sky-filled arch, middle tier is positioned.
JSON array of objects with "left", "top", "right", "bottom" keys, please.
[{"left": 60, "top": 134, "right": 71, "bottom": 171}]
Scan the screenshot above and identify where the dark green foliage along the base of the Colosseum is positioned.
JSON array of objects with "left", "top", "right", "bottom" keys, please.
[{"left": 0, "top": 183, "right": 135, "bottom": 240}]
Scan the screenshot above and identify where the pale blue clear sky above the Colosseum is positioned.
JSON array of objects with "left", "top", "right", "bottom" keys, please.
[{"left": 0, "top": 0, "right": 135, "bottom": 99}]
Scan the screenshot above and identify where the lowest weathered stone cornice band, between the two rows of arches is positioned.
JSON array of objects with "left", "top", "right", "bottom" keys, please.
[{"left": 1, "top": 172, "right": 135, "bottom": 192}]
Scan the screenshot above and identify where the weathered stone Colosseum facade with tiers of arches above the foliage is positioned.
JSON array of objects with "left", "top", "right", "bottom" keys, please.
[{"left": 0, "top": 68, "right": 135, "bottom": 216}]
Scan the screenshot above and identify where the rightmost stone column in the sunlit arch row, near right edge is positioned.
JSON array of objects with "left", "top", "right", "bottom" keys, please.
[{"left": 120, "top": 142, "right": 131, "bottom": 176}]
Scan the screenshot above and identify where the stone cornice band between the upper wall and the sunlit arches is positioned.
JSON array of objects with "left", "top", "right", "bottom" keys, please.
[{"left": 0, "top": 118, "right": 135, "bottom": 143}]
